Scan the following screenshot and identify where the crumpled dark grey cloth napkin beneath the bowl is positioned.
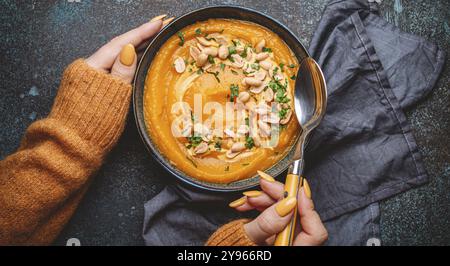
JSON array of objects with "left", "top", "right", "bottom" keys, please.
[{"left": 143, "top": 0, "right": 444, "bottom": 245}]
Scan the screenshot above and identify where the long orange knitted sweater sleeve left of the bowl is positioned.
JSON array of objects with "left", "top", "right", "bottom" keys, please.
[{"left": 0, "top": 59, "right": 131, "bottom": 245}]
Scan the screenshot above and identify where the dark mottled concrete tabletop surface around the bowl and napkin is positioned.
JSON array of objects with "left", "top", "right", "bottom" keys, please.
[{"left": 0, "top": 0, "right": 450, "bottom": 245}]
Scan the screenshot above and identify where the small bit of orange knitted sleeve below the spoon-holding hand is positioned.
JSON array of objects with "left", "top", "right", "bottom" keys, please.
[{"left": 206, "top": 219, "right": 256, "bottom": 246}]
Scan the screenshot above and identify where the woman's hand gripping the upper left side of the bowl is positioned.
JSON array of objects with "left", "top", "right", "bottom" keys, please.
[{"left": 86, "top": 15, "right": 173, "bottom": 83}]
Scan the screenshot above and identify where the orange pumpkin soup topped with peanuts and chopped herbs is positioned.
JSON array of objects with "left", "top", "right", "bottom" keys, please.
[{"left": 144, "top": 19, "right": 300, "bottom": 183}]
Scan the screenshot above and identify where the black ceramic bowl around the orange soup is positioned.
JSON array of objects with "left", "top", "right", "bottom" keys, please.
[{"left": 133, "top": 5, "right": 309, "bottom": 192}]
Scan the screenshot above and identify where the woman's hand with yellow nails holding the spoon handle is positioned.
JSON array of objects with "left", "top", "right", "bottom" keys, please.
[{"left": 230, "top": 172, "right": 328, "bottom": 246}]
